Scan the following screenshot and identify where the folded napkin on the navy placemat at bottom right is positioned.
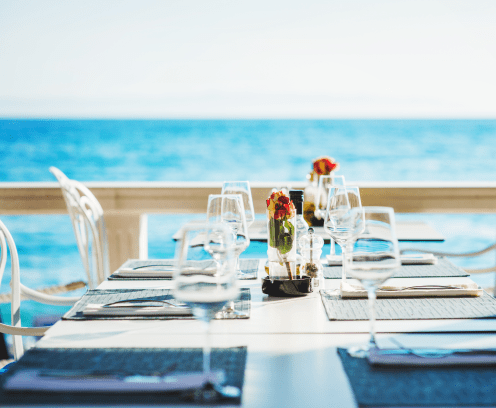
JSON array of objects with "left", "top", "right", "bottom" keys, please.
[{"left": 368, "top": 348, "right": 496, "bottom": 367}]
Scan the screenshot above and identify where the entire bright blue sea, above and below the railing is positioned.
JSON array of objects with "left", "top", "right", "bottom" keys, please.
[{"left": 0, "top": 119, "right": 496, "bottom": 348}]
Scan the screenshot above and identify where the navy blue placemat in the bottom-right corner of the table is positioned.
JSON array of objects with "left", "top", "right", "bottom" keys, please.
[{"left": 338, "top": 349, "right": 496, "bottom": 407}]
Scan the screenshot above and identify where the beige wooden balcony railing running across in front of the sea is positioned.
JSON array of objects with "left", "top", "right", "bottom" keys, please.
[{"left": 0, "top": 182, "right": 496, "bottom": 271}]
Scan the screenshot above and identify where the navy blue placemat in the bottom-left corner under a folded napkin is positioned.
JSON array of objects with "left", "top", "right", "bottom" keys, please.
[{"left": 0, "top": 347, "right": 247, "bottom": 407}]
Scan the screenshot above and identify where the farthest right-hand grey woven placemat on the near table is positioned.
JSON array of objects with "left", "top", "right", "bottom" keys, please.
[{"left": 322, "top": 258, "right": 469, "bottom": 279}]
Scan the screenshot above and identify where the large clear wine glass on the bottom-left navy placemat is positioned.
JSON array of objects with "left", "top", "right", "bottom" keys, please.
[{"left": 172, "top": 223, "right": 239, "bottom": 399}]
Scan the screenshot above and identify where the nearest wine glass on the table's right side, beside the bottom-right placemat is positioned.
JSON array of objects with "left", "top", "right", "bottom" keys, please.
[{"left": 346, "top": 207, "right": 401, "bottom": 357}]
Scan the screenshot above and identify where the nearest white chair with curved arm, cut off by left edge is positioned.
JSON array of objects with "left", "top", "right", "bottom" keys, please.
[{"left": 0, "top": 221, "right": 80, "bottom": 360}]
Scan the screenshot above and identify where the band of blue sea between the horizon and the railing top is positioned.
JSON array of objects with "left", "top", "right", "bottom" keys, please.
[{"left": 0, "top": 120, "right": 496, "bottom": 181}]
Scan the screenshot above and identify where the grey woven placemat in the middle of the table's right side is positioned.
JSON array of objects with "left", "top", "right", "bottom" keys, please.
[{"left": 320, "top": 290, "right": 496, "bottom": 320}]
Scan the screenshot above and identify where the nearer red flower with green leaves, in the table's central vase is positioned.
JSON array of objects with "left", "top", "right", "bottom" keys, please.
[{"left": 267, "top": 191, "right": 296, "bottom": 279}]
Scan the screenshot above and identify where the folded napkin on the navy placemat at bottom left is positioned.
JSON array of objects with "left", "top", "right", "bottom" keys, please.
[{"left": 4, "top": 369, "right": 224, "bottom": 393}]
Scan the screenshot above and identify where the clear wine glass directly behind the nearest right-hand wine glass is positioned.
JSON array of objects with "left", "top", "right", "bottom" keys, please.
[{"left": 324, "top": 186, "right": 364, "bottom": 283}]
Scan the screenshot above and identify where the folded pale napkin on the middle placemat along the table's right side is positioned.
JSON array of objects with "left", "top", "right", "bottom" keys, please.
[{"left": 340, "top": 280, "right": 484, "bottom": 298}]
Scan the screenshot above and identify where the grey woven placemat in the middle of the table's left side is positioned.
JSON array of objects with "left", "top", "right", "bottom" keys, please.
[{"left": 62, "top": 288, "right": 251, "bottom": 320}]
